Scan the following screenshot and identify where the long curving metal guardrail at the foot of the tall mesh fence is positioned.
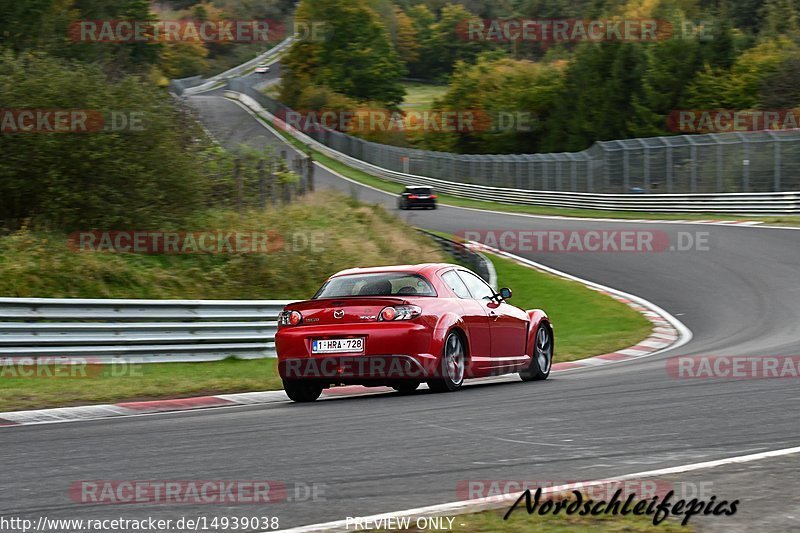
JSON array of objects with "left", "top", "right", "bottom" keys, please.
[{"left": 226, "top": 86, "right": 800, "bottom": 215}]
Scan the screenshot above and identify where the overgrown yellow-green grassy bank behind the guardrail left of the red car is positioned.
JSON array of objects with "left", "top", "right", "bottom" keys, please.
[{"left": 0, "top": 192, "right": 444, "bottom": 300}]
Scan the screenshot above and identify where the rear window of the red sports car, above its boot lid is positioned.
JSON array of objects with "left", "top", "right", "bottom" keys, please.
[{"left": 313, "top": 272, "right": 436, "bottom": 300}]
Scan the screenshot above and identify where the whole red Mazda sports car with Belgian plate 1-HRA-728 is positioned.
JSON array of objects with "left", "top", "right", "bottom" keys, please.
[{"left": 275, "top": 264, "right": 553, "bottom": 402}]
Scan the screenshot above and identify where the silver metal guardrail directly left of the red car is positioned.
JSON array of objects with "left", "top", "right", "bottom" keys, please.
[{"left": 0, "top": 298, "right": 291, "bottom": 363}]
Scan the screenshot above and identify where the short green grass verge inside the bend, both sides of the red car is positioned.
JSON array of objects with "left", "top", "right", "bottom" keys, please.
[{"left": 0, "top": 247, "right": 650, "bottom": 411}]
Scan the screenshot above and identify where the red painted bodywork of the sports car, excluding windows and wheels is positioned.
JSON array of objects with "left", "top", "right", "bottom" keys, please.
[{"left": 275, "top": 264, "right": 549, "bottom": 386}]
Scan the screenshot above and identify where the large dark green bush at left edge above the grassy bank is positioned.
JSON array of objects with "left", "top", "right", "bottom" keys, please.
[{"left": 0, "top": 51, "right": 207, "bottom": 229}]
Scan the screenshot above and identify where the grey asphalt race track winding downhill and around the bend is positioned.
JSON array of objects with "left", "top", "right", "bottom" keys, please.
[{"left": 0, "top": 77, "right": 800, "bottom": 531}]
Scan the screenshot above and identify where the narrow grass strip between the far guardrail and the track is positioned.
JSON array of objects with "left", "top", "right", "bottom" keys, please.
[{"left": 261, "top": 114, "right": 800, "bottom": 226}]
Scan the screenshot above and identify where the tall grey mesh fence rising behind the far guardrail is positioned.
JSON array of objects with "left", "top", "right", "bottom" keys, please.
[{"left": 230, "top": 80, "right": 800, "bottom": 195}]
